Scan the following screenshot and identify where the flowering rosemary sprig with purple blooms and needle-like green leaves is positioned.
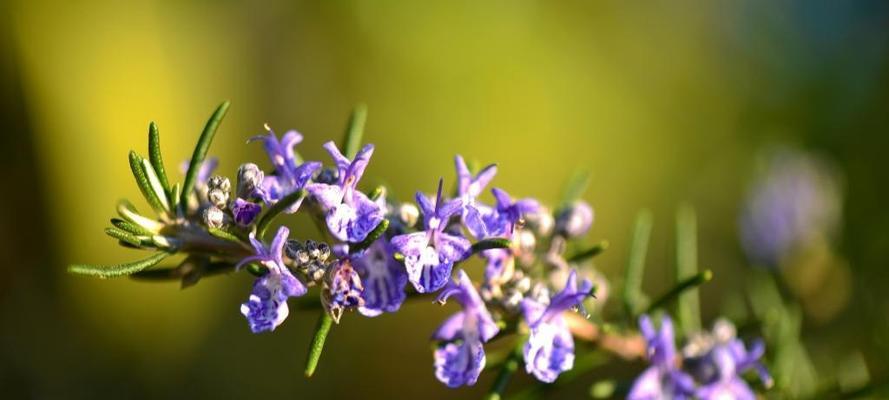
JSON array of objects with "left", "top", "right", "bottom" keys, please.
[{"left": 70, "top": 103, "right": 769, "bottom": 399}]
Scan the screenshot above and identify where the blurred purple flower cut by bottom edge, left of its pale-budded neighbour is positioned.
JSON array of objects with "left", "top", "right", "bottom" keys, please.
[{"left": 627, "top": 315, "right": 694, "bottom": 400}]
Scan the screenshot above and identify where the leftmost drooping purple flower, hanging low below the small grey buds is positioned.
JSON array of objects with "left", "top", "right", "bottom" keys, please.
[{"left": 236, "top": 226, "right": 306, "bottom": 333}]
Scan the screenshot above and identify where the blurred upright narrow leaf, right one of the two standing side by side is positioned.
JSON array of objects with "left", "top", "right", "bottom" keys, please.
[{"left": 676, "top": 204, "right": 701, "bottom": 335}]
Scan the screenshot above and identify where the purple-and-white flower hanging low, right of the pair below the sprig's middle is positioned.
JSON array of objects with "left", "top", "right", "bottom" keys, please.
[{"left": 522, "top": 270, "right": 593, "bottom": 382}]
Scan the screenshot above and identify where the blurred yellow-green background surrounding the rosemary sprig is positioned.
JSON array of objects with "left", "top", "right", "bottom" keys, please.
[{"left": 0, "top": 0, "right": 889, "bottom": 398}]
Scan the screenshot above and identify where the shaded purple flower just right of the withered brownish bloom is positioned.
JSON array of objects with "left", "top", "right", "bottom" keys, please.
[{"left": 352, "top": 238, "right": 407, "bottom": 317}]
